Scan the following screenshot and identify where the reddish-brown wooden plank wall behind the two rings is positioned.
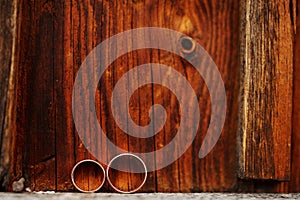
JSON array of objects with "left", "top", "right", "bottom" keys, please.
[{"left": 0, "top": 0, "right": 300, "bottom": 192}]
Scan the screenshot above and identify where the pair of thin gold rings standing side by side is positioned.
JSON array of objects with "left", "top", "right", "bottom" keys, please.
[{"left": 71, "top": 153, "right": 147, "bottom": 194}]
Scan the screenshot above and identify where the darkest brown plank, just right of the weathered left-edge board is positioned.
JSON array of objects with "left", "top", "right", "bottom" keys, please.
[{"left": 18, "top": 1, "right": 56, "bottom": 190}]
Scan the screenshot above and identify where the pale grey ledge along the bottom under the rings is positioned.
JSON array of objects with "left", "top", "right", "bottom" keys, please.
[{"left": 0, "top": 192, "right": 300, "bottom": 200}]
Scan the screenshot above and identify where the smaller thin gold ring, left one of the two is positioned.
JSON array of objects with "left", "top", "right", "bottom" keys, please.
[{"left": 71, "top": 159, "right": 105, "bottom": 193}]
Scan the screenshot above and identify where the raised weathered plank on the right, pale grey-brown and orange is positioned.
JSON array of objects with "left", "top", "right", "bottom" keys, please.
[{"left": 238, "top": 0, "right": 294, "bottom": 180}]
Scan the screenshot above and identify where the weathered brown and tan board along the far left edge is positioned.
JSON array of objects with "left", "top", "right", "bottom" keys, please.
[{"left": 0, "top": 1, "right": 17, "bottom": 188}]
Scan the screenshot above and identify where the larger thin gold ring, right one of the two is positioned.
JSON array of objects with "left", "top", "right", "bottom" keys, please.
[{"left": 106, "top": 153, "right": 147, "bottom": 194}]
